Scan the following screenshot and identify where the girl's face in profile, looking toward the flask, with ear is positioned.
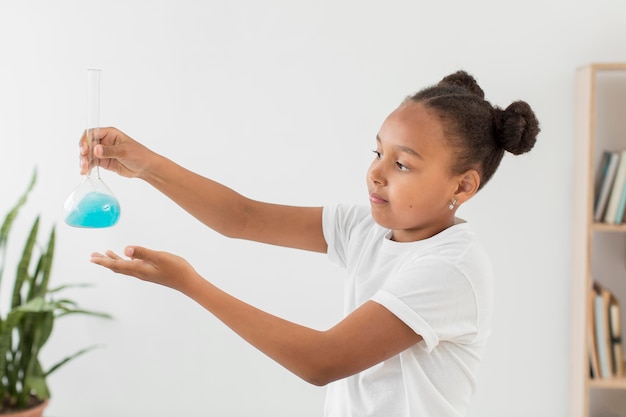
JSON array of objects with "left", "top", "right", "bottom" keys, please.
[{"left": 367, "top": 101, "right": 467, "bottom": 242}]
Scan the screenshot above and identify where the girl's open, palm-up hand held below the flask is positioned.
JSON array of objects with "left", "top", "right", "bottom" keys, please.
[{"left": 91, "top": 246, "right": 200, "bottom": 292}]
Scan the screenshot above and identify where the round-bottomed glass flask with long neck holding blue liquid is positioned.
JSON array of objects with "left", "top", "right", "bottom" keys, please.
[{"left": 63, "top": 69, "right": 120, "bottom": 228}]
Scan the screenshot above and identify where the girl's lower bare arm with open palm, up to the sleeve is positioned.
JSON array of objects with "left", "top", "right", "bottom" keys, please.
[{"left": 92, "top": 247, "right": 421, "bottom": 385}]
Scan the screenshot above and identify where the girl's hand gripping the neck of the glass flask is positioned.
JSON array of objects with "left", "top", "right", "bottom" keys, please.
[{"left": 79, "top": 127, "right": 157, "bottom": 178}]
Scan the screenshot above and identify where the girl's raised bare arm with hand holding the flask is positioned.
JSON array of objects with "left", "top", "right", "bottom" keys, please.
[{"left": 80, "top": 128, "right": 327, "bottom": 252}]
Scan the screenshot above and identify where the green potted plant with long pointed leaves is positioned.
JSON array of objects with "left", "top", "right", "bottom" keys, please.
[{"left": 0, "top": 171, "right": 109, "bottom": 417}]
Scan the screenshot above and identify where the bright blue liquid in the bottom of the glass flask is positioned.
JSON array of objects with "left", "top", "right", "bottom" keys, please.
[{"left": 65, "top": 191, "right": 120, "bottom": 228}]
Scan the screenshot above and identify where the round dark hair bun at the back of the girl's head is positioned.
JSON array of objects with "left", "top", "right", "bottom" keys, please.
[{"left": 494, "top": 101, "right": 540, "bottom": 155}]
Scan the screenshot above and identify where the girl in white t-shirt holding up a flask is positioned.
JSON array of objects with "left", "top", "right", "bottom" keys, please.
[{"left": 81, "top": 71, "right": 539, "bottom": 417}]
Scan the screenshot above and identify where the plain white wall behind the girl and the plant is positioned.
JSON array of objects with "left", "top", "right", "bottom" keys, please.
[{"left": 0, "top": 0, "right": 626, "bottom": 417}]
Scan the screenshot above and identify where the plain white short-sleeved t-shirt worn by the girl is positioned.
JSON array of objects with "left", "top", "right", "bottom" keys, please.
[{"left": 323, "top": 205, "right": 493, "bottom": 417}]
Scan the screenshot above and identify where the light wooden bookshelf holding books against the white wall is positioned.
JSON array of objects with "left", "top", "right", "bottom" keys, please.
[{"left": 569, "top": 63, "right": 626, "bottom": 417}]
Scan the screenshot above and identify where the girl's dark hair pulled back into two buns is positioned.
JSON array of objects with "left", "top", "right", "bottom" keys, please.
[{"left": 409, "top": 71, "right": 540, "bottom": 189}]
